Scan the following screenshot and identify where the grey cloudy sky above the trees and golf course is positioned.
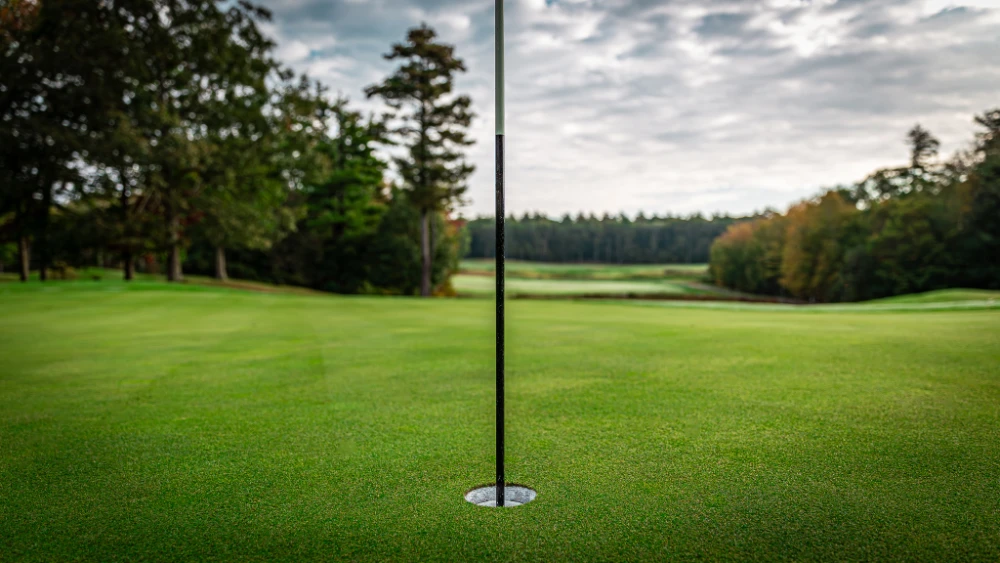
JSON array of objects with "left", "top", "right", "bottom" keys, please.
[{"left": 263, "top": 0, "right": 1000, "bottom": 215}]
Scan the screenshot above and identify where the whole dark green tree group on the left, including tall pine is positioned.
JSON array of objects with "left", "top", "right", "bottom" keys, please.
[{"left": 0, "top": 0, "right": 473, "bottom": 295}]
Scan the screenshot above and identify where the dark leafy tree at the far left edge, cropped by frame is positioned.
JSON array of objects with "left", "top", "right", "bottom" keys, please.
[{"left": 0, "top": 0, "right": 110, "bottom": 280}]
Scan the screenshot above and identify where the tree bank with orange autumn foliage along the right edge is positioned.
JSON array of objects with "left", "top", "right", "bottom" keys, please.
[{"left": 709, "top": 109, "right": 1000, "bottom": 302}]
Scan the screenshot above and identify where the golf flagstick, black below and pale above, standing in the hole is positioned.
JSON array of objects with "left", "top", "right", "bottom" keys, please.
[{"left": 495, "top": 0, "right": 506, "bottom": 506}]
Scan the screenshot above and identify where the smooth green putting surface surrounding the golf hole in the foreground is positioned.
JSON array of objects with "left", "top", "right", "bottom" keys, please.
[{"left": 0, "top": 282, "right": 1000, "bottom": 561}]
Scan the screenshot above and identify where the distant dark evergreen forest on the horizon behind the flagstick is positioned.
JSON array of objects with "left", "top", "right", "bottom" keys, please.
[{"left": 467, "top": 213, "right": 745, "bottom": 264}]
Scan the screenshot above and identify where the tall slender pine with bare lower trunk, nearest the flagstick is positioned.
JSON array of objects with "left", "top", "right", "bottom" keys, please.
[{"left": 365, "top": 24, "right": 474, "bottom": 296}]
